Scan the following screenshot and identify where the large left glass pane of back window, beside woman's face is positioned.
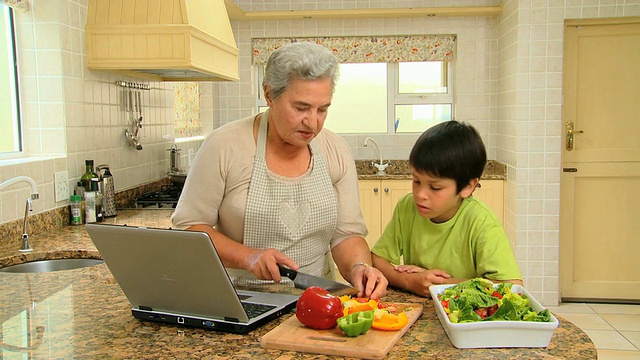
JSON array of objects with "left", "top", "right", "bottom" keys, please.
[{"left": 325, "top": 63, "right": 387, "bottom": 134}]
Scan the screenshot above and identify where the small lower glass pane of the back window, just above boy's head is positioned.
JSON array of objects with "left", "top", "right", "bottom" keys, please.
[{"left": 395, "top": 104, "right": 451, "bottom": 133}]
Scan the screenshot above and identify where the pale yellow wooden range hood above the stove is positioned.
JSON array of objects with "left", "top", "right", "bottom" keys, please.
[{"left": 85, "top": 0, "right": 239, "bottom": 81}]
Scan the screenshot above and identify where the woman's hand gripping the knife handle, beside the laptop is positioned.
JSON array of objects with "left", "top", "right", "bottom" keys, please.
[{"left": 243, "top": 249, "right": 298, "bottom": 282}]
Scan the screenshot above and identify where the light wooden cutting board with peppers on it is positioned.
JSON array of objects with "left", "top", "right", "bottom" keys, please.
[{"left": 260, "top": 303, "right": 422, "bottom": 359}]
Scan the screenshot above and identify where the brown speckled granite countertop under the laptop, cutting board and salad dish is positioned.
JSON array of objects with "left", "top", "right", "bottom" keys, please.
[{"left": 0, "top": 210, "right": 596, "bottom": 360}]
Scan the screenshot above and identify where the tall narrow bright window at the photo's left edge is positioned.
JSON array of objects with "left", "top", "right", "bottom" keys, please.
[{"left": 0, "top": 6, "right": 22, "bottom": 155}]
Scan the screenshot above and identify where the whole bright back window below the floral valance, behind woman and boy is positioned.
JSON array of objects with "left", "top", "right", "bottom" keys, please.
[{"left": 252, "top": 61, "right": 453, "bottom": 134}]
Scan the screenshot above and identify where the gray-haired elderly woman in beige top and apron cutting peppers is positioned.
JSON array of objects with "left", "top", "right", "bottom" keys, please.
[{"left": 172, "top": 42, "right": 388, "bottom": 298}]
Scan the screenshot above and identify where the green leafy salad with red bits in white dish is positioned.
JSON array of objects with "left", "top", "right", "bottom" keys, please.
[{"left": 438, "top": 278, "right": 551, "bottom": 323}]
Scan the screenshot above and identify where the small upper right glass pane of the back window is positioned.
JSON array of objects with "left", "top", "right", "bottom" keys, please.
[{"left": 398, "top": 61, "right": 447, "bottom": 94}]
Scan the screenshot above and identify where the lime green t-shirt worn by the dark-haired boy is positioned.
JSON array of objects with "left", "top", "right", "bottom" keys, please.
[{"left": 371, "top": 194, "right": 522, "bottom": 280}]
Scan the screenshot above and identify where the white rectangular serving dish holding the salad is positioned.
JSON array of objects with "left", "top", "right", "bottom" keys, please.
[{"left": 429, "top": 284, "right": 558, "bottom": 349}]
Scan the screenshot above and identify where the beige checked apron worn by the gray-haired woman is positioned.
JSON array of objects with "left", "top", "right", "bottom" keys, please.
[{"left": 230, "top": 110, "right": 338, "bottom": 285}]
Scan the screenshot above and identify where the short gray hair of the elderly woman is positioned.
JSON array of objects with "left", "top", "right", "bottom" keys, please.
[{"left": 262, "top": 42, "right": 340, "bottom": 100}]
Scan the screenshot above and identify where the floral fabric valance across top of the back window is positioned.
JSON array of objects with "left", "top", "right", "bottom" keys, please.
[{"left": 252, "top": 35, "right": 456, "bottom": 65}]
